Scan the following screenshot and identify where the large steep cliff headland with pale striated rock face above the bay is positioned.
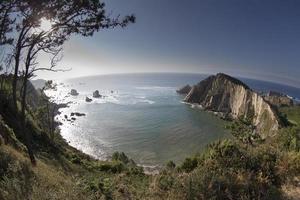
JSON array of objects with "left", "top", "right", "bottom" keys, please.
[{"left": 184, "top": 74, "right": 279, "bottom": 137}]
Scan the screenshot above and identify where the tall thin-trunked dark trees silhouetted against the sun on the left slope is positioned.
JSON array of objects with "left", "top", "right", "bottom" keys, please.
[{"left": 8, "top": 0, "right": 135, "bottom": 164}]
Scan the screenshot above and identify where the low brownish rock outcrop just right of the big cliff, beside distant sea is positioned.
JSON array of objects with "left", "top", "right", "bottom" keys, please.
[{"left": 264, "top": 91, "right": 294, "bottom": 107}]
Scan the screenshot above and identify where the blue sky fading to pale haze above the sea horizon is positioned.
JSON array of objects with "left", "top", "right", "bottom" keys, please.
[{"left": 38, "top": 0, "right": 300, "bottom": 88}]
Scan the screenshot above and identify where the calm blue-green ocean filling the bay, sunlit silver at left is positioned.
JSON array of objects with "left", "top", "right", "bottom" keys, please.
[{"left": 47, "top": 73, "right": 300, "bottom": 168}]
